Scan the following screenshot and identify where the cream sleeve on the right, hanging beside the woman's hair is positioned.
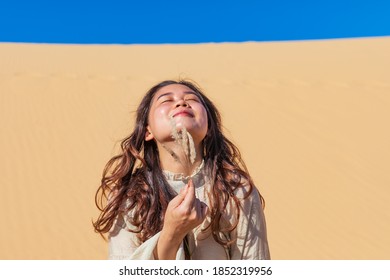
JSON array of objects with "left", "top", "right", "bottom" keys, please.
[{"left": 230, "top": 184, "right": 270, "bottom": 260}]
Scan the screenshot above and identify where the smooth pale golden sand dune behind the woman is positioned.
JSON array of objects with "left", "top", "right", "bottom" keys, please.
[{"left": 0, "top": 37, "right": 390, "bottom": 260}]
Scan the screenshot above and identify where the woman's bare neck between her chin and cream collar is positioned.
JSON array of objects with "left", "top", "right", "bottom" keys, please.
[{"left": 157, "top": 142, "right": 203, "bottom": 176}]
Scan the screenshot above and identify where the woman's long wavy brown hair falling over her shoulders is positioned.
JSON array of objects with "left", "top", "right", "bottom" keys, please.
[{"left": 93, "top": 80, "right": 264, "bottom": 257}]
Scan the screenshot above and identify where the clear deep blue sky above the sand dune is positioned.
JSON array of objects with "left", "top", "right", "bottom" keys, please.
[{"left": 0, "top": 0, "right": 390, "bottom": 44}]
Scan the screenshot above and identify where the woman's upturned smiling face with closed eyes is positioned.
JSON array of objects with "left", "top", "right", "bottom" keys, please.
[{"left": 145, "top": 84, "right": 208, "bottom": 144}]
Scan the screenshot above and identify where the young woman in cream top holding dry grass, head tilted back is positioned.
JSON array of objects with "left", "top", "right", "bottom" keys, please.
[{"left": 94, "top": 80, "right": 270, "bottom": 260}]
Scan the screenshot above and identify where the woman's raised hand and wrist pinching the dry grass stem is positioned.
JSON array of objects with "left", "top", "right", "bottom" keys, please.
[{"left": 156, "top": 181, "right": 208, "bottom": 260}]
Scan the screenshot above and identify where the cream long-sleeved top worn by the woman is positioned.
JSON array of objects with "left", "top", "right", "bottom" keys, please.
[{"left": 109, "top": 163, "right": 270, "bottom": 260}]
